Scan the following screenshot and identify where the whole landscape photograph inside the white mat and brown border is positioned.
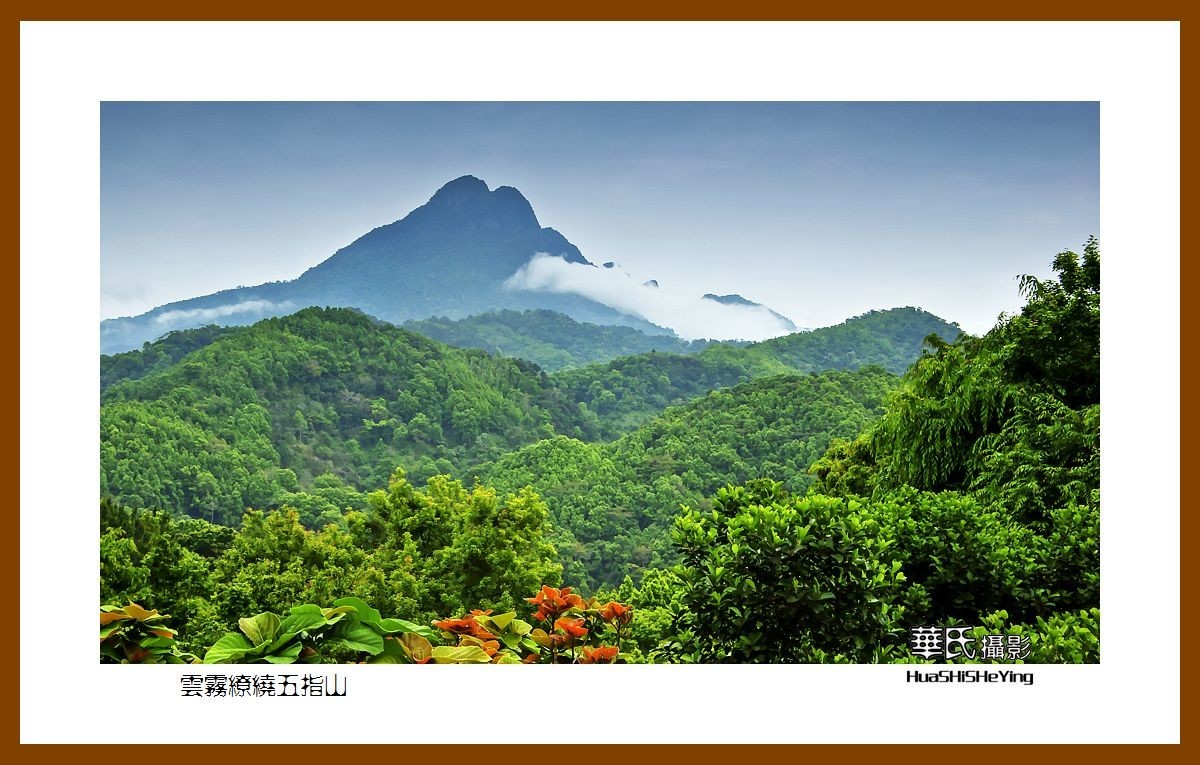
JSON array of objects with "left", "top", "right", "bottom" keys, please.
[{"left": 98, "top": 101, "right": 1103, "bottom": 677}]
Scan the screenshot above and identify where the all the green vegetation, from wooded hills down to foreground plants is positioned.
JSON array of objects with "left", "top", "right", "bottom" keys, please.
[{"left": 101, "top": 240, "right": 1099, "bottom": 662}]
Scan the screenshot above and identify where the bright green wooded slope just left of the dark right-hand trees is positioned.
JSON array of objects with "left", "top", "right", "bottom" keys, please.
[{"left": 476, "top": 367, "right": 898, "bottom": 589}]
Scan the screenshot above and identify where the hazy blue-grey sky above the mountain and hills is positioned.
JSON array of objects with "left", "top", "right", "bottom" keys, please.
[{"left": 101, "top": 102, "right": 1103, "bottom": 332}]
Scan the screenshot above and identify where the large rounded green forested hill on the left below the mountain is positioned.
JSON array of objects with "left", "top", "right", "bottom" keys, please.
[{"left": 101, "top": 308, "right": 594, "bottom": 525}]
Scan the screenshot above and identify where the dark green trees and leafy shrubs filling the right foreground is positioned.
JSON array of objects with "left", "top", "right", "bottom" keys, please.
[{"left": 652, "top": 239, "right": 1100, "bottom": 662}]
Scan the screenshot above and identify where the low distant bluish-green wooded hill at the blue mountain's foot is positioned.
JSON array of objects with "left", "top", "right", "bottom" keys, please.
[{"left": 404, "top": 311, "right": 712, "bottom": 372}]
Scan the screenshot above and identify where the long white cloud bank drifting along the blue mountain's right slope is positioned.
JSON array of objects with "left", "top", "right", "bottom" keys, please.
[{"left": 504, "top": 253, "right": 794, "bottom": 341}]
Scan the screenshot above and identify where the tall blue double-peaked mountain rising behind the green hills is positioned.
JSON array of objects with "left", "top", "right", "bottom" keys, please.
[{"left": 101, "top": 175, "right": 667, "bottom": 354}]
